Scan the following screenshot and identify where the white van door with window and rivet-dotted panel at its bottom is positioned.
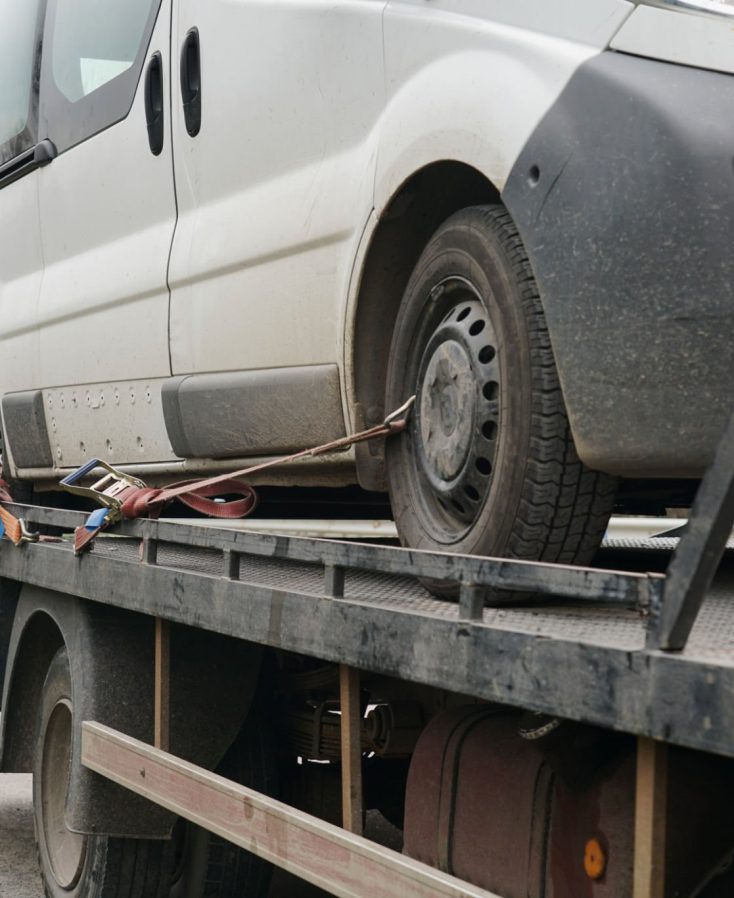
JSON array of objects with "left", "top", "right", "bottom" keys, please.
[{"left": 29, "top": 0, "right": 181, "bottom": 468}]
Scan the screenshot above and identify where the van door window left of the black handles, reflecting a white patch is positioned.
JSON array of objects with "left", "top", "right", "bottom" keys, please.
[{"left": 41, "top": 0, "right": 160, "bottom": 152}]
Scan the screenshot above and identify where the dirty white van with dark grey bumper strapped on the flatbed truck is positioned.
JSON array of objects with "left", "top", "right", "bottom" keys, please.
[{"left": 0, "top": 0, "right": 734, "bottom": 562}]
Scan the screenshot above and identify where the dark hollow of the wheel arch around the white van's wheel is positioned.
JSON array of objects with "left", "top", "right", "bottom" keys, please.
[{"left": 349, "top": 160, "right": 500, "bottom": 490}]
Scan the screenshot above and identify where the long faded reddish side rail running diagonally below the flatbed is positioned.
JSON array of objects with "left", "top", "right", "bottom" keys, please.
[{"left": 82, "top": 722, "right": 499, "bottom": 898}]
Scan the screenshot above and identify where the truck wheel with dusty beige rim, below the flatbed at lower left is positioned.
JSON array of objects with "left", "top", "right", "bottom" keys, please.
[{"left": 33, "top": 648, "right": 169, "bottom": 898}]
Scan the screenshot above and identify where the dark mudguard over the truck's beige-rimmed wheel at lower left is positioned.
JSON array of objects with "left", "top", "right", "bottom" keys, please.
[{"left": 0, "top": 586, "right": 262, "bottom": 838}]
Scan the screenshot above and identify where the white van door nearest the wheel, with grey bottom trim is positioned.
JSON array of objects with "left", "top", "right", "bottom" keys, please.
[{"left": 165, "top": 0, "right": 385, "bottom": 457}]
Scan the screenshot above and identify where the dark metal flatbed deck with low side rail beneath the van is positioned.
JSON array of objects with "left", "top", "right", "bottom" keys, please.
[{"left": 5, "top": 506, "right": 734, "bottom": 757}]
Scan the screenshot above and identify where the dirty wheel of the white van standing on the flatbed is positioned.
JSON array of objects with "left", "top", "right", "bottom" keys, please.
[{"left": 386, "top": 206, "right": 615, "bottom": 594}]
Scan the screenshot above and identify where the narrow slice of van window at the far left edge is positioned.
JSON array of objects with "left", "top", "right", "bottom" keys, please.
[{"left": 0, "top": 0, "right": 42, "bottom": 165}]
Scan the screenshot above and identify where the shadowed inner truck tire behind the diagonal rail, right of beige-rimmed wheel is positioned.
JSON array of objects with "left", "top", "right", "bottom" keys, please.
[{"left": 169, "top": 719, "right": 278, "bottom": 898}]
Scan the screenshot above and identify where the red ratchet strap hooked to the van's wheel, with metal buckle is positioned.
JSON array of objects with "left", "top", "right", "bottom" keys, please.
[{"left": 74, "top": 396, "right": 415, "bottom": 554}]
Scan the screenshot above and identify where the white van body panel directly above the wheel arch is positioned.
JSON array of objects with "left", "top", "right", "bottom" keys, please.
[{"left": 375, "top": 0, "right": 633, "bottom": 205}]
